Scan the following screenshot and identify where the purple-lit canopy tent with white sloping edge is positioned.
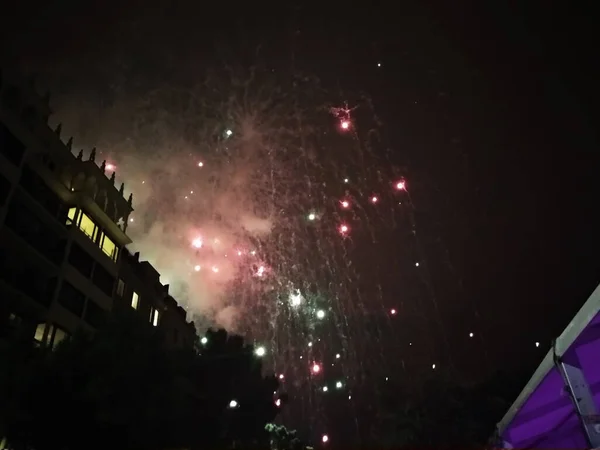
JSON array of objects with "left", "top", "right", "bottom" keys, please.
[{"left": 497, "top": 286, "right": 600, "bottom": 449}]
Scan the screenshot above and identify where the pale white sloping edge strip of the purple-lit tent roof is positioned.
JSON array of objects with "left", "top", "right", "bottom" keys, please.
[{"left": 497, "top": 285, "right": 600, "bottom": 436}]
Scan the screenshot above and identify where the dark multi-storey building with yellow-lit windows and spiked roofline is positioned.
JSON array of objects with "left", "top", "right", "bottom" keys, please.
[{"left": 0, "top": 68, "right": 195, "bottom": 346}]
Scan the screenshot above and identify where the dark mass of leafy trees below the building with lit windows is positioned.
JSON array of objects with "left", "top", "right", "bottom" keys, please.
[{"left": 0, "top": 314, "right": 277, "bottom": 450}]
